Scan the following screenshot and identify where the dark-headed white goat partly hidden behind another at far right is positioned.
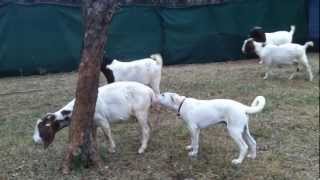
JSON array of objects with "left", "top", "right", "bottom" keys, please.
[{"left": 250, "top": 25, "right": 296, "bottom": 45}]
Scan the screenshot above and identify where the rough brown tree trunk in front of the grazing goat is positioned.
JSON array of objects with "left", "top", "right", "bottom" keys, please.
[{"left": 62, "top": 0, "right": 117, "bottom": 174}]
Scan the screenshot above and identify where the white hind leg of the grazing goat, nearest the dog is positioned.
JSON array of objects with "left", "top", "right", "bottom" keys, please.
[{"left": 136, "top": 111, "right": 150, "bottom": 154}]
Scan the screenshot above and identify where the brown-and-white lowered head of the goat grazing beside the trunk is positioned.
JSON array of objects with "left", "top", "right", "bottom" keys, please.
[{"left": 33, "top": 110, "right": 71, "bottom": 148}]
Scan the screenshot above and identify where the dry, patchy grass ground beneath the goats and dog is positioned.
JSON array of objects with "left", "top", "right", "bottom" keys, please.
[{"left": 0, "top": 54, "right": 319, "bottom": 180}]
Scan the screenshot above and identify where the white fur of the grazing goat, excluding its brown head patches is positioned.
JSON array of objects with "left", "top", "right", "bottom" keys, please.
[{"left": 33, "top": 81, "right": 156, "bottom": 153}]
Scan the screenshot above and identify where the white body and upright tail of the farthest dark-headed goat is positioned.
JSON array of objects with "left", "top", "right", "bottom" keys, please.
[{"left": 265, "top": 25, "right": 295, "bottom": 45}]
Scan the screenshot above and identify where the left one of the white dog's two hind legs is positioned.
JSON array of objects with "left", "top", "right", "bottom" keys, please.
[{"left": 228, "top": 126, "right": 248, "bottom": 164}]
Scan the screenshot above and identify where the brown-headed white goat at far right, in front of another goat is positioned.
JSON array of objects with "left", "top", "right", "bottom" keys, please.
[{"left": 242, "top": 38, "right": 313, "bottom": 81}]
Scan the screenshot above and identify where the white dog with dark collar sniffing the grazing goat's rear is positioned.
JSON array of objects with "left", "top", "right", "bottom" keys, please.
[{"left": 158, "top": 92, "right": 265, "bottom": 164}]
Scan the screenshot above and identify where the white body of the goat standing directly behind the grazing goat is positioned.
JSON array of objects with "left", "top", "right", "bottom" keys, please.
[{"left": 107, "top": 54, "right": 163, "bottom": 94}]
